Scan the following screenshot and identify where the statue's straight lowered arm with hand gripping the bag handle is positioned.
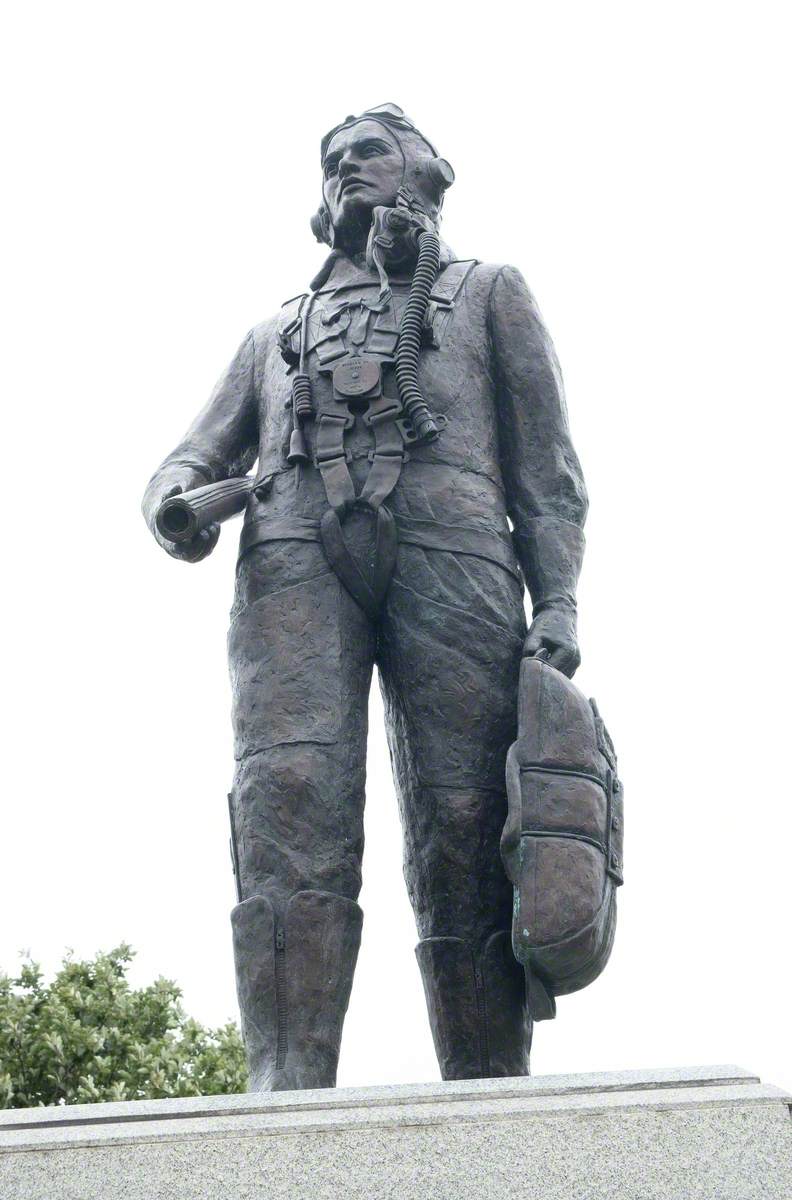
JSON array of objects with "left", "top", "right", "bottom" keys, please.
[{"left": 490, "top": 266, "right": 588, "bottom": 676}]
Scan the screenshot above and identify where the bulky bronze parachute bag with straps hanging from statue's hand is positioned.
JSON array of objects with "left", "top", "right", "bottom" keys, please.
[{"left": 500, "top": 659, "right": 624, "bottom": 1021}]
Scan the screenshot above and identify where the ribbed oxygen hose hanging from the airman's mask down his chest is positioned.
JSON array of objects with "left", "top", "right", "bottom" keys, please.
[{"left": 396, "top": 232, "right": 440, "bottom": 442}]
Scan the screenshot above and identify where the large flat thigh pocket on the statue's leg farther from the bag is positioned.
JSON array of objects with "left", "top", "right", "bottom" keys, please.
[{"left": 228, "top": 574, "right": 341, "bottom": 758}]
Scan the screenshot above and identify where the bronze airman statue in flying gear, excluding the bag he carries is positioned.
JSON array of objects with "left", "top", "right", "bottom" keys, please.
[{"left": 144, "top": 104, "right": 618, "bottom": 1090}]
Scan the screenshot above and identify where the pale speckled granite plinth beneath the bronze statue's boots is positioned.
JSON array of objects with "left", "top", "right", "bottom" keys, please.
[{"left": 0, "top": 1067, "right": 792, "bottom": 1200}]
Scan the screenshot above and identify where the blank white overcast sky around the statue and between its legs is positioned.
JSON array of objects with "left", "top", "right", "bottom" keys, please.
[{"left": 0, "top": 0, "right": 792, "bottom": 1088}]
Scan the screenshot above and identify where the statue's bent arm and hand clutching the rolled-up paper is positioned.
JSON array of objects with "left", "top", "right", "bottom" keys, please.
[{"left": 143, "top": 331, "right": 258, "bottom": 563}]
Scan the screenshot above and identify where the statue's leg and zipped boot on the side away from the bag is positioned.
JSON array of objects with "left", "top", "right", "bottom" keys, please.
[{"left": 229, "top": 544, "right": 373, "bottom": 1091}]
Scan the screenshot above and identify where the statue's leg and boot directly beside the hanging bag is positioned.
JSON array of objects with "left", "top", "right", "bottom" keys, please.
[{"left": 379, "top": 546, "right": 530, "bottom": 1079}]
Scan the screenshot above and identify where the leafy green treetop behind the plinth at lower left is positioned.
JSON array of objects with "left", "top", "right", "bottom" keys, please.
[{"left": 0, "top": 946, "right": 247, "bottom": 1109}]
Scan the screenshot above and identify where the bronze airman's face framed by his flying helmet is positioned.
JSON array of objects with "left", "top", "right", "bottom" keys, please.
[{"left": 322, "top": 121, "right": 404, "bottom": 240}]
